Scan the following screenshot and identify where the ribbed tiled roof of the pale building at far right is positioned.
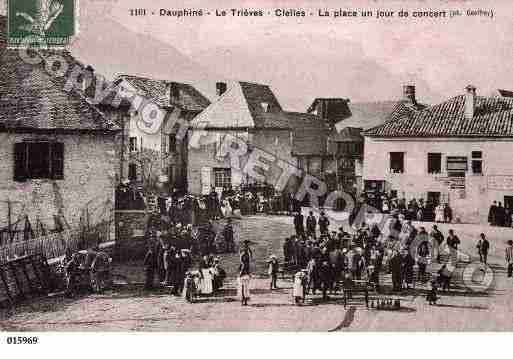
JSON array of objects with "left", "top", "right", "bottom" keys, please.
[{"left": 364, "top": 95, "right": 513, "bottom": 137}]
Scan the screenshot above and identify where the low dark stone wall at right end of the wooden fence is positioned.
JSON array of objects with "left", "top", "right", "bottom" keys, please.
[{"left": 114, "top": 210, "right": 150, "bottom": 261}]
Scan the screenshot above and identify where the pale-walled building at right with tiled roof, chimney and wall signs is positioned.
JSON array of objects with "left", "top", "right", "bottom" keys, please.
[{"left": 363, "top": 86, "right": 513, "bottom": 223}]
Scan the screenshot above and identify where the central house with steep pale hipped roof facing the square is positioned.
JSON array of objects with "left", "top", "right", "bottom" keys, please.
[{"left": 187, "top": 82, "right": 297, "bottom": 194}]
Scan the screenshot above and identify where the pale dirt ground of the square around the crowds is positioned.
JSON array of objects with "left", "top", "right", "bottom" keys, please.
[{"left": 0, "top": 216, "right": 513, "bottom": 332}]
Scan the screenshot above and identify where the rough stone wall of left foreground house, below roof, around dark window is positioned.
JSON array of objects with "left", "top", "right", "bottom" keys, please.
[{"left": 0, "top": 133, "right": 119, "bottom": 229}]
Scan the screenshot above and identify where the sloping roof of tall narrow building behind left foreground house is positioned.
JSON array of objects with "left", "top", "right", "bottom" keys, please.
[{"left": 118, "top": 75, "right": 210, "bottom": 112}]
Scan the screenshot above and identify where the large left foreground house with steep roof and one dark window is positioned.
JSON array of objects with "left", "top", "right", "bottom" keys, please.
[{"left": 0, "top": 43, "right": 120, "bottom": 230}]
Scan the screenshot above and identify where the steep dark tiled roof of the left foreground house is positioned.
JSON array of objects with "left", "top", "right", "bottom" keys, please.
[{"left": 0, "top": 17, "right": 119, "bottom": 131}]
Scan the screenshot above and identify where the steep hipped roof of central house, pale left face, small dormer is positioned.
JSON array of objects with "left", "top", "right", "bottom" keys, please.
[{"left": 191, "top": 82, "right": 290, "bottom": 129}]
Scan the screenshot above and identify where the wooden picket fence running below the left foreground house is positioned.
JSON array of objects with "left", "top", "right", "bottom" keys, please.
[{"left": 0, "top": 222, "right": 110, "bottom": 263}]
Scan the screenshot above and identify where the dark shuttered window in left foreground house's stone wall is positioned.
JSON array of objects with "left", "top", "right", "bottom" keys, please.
[{"left": 14, "top": 141, "right": 64, "bottom": 182}]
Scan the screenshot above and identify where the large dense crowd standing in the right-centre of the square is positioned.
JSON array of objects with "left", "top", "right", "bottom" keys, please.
[{"left": 283, "top": 212, "right": 488, "bottom": 302}]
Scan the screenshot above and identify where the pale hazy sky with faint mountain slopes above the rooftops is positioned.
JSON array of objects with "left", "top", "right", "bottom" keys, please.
[{"left": 1, "top": 0, "right": 513, "bottom": 110}]
